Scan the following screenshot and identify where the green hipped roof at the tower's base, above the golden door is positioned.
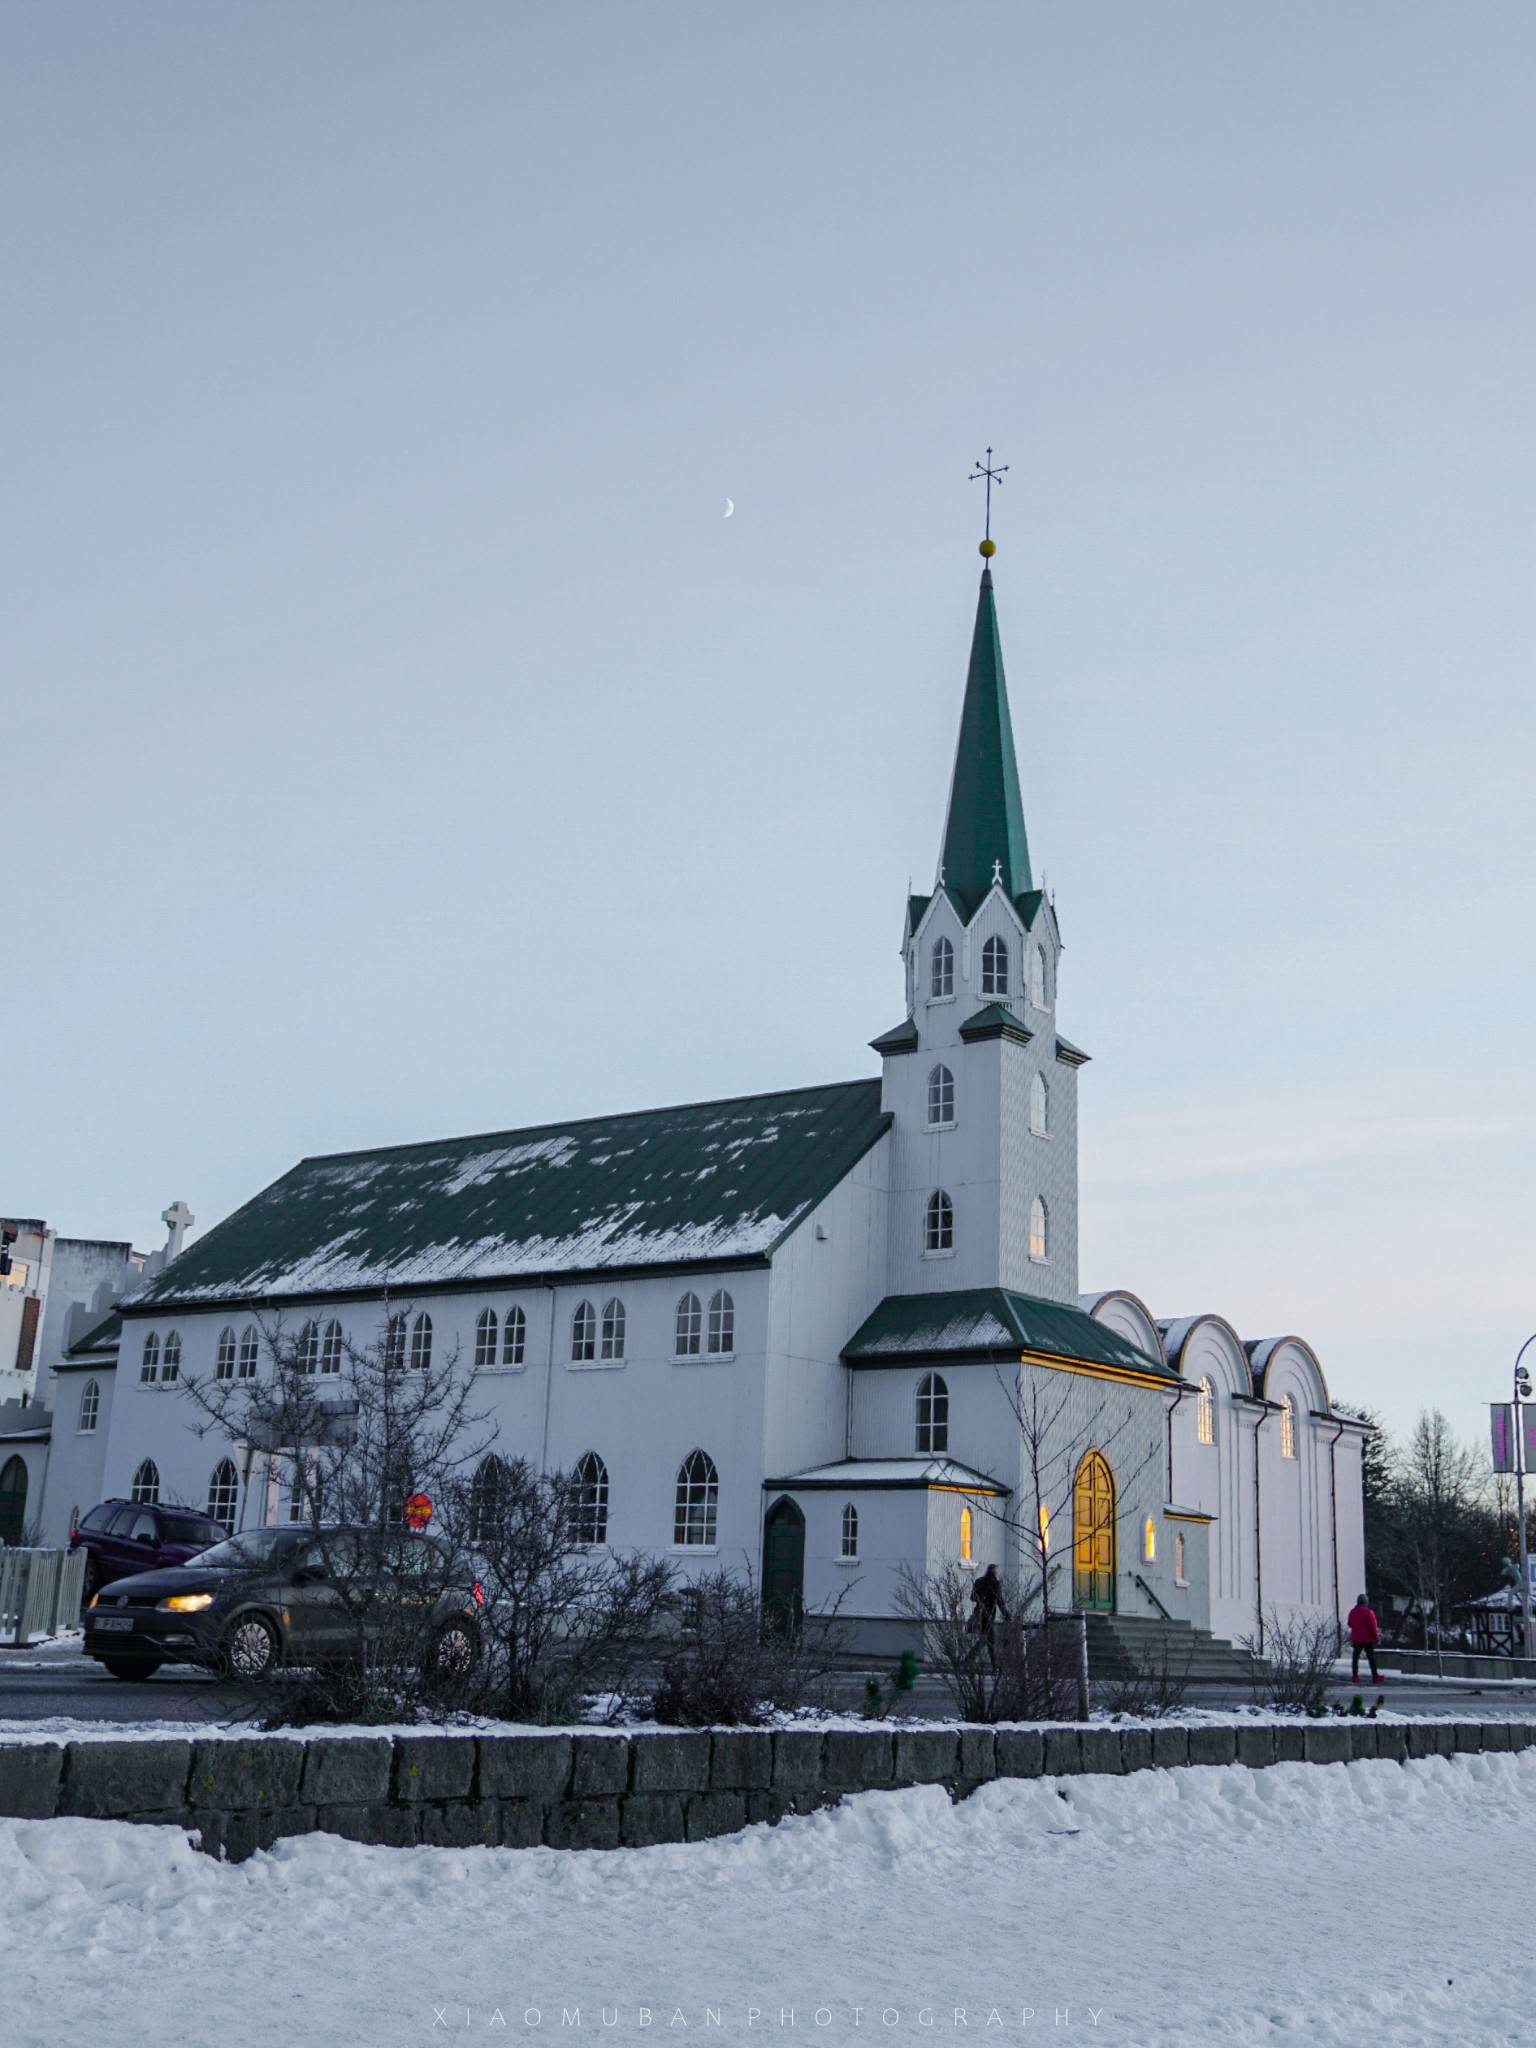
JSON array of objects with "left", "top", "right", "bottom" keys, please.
[{"left": 842, "top": 1286, "right": 1178, "bottom": 1380}]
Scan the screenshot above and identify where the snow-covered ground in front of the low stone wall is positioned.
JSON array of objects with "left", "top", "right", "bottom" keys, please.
[{"left": 0, "top": 1751, "right": 1536, "bottom": 2048}]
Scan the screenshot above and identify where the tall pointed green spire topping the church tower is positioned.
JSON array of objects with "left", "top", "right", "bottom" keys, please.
[{"left": 940, "top": 563, "right": 1034, "bottom": 918}]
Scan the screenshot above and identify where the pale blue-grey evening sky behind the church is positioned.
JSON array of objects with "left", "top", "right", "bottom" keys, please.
[{"left": 0, "top": 0, "right": 1536, "bottom": 1436}]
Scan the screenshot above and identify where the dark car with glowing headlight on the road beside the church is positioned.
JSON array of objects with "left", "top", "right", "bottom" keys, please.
[{"left": 84, "top": 1528, "right": 481, "bottom": 1683}]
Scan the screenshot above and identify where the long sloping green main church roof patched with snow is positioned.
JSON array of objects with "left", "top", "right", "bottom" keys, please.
[{"left": 141, "top": 1079, "right": 891, "bottom": 1315}]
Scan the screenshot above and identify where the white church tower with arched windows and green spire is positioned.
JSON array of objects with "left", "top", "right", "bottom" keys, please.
[{"left": 874, "top": 543, "right": 1087, "bottom": 1303}]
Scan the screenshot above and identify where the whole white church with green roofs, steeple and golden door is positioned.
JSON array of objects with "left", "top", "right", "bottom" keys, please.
[{"left": 47, "top": 567, "right": 1366, "bottom": 1651}]
